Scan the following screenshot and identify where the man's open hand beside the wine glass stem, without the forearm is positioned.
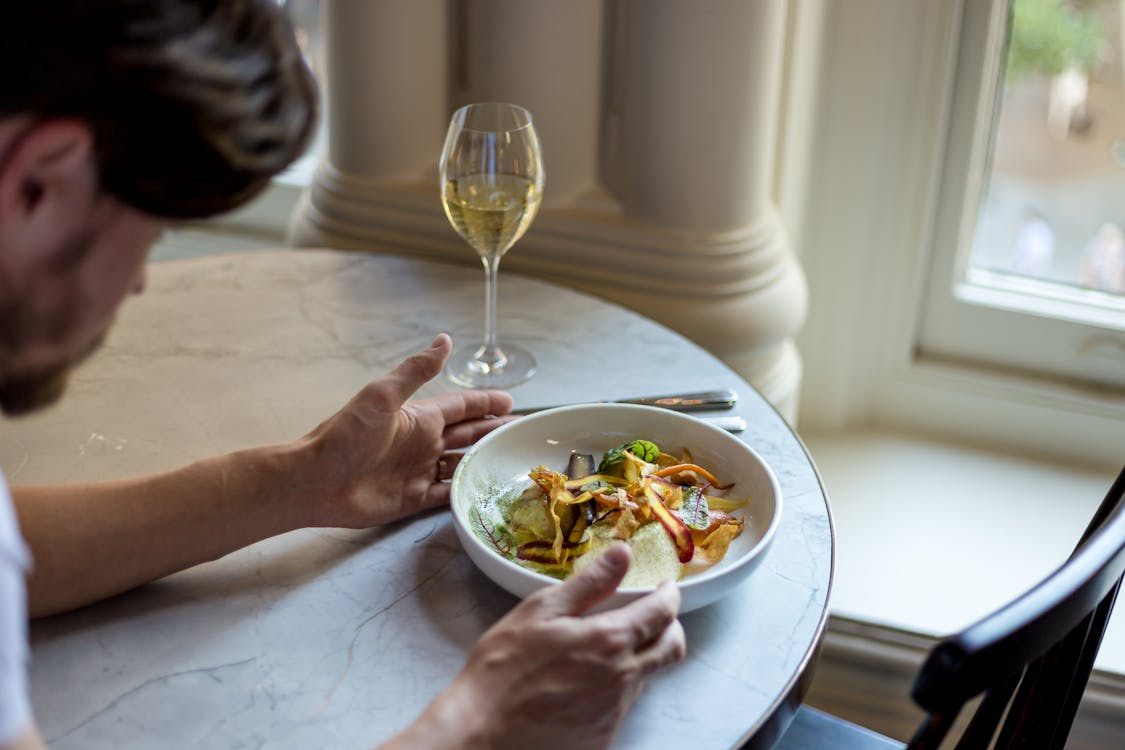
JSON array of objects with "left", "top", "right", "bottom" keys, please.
[{"left": 294, "top": 334, "right": 512, "bottom": 527}]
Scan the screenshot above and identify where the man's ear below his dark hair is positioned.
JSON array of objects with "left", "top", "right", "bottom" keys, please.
[{"left": 0, "top": 120, "right": 98, "bottom": 231}]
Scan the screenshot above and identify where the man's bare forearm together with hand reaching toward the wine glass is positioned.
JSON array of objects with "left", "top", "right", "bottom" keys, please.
[{"left": 14, "top": 334, "right": 512, "bottom": 616}]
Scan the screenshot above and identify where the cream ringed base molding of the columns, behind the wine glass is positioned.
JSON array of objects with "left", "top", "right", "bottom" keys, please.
[{"left": 289, "top": 164, "right": 807, "bottom": 422}]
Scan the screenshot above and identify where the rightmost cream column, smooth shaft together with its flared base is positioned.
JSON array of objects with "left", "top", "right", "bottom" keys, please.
[{"left": 608, "top": 0, "right": 807, "bottom": 415}]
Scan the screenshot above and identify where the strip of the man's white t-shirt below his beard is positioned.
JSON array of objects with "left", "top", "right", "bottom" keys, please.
[{"left": 0, "top": 473, "right": 32, "bottom": 743}]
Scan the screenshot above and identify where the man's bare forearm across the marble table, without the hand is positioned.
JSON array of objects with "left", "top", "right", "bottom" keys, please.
[{"left": 12, "top": 445, "right": 306, "bottom": 617}]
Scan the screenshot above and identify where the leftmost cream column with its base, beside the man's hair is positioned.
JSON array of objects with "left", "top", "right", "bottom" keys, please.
[{"left": 289, "top": 0, "right": 449, "bottom": 251}]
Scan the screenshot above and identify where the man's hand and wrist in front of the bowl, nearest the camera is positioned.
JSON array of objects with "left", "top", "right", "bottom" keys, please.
[{"left": 385, "top": 544, "right": 685, "bottom": 750}]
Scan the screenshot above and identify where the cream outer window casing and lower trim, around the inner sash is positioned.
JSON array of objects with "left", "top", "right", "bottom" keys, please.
[{"left": 779, "top": 0, "right": 1125, "bottom": 467}]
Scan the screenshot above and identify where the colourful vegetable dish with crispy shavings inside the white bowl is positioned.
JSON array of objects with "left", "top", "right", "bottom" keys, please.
[{"left": 469, "top": 439, "right": 747, "bottom": 586}]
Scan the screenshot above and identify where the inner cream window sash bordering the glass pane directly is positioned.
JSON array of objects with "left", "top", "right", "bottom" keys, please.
[{"left": 918, "top": 0, "right": 1125, "bottom": 388}]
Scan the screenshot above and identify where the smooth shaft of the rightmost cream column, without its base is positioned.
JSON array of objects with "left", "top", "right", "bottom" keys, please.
[{"left": 620, "top": 0, "right": 784, "bottom": 233}]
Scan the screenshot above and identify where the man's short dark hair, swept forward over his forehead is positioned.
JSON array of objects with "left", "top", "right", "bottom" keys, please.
[{"left": 0, "top": 0, "right": 317, "bottom": 218}]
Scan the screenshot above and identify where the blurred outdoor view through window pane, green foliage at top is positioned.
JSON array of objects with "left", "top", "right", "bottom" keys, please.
[{"left": 970, "top": 0, "right": 1125, "bottom": 305}]
